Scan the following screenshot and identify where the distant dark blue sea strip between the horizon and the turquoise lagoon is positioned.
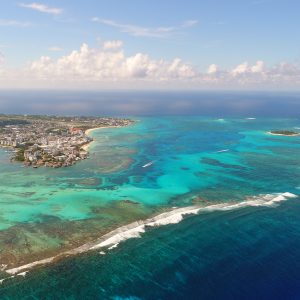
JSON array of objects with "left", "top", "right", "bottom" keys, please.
[{"left": 0, "top": 90, "right": 300, "bottom": 117}]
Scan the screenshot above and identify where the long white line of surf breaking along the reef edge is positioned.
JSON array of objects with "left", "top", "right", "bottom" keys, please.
[{"left": 0, "top": 192, "right": 298, "bottom": 283}]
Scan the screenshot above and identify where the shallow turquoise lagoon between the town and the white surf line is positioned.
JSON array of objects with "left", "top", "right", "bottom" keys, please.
[{"left": 0, "top": 117, "right": 300, "bottom": 292}]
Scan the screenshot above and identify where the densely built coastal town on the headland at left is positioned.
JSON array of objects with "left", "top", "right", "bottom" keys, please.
[{"left": 0, "top": 115, "right": 133, "bottom": 168}]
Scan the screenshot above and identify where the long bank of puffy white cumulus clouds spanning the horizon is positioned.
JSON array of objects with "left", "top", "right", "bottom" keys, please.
[{"left": 0, "top": 40, "right": 300, "bottom": 89}]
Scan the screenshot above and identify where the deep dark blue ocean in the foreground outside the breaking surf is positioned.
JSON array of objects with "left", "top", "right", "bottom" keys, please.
[{"left": 0, "top": 200, "right": 300, "bottom": 299}]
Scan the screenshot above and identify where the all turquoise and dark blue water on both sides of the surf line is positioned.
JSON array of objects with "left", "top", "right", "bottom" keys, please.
[{"left": 0, "top": 116, "right": 300, "bottom": 299}]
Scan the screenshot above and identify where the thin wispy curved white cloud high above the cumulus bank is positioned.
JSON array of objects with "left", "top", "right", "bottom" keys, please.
[{"left": 92, "top": 17, "right": 198, "bottom": 38}]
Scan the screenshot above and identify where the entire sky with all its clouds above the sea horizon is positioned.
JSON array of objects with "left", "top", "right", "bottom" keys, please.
[{"left": 0, "top": 0, "right": 300, "bottom": 90}]
